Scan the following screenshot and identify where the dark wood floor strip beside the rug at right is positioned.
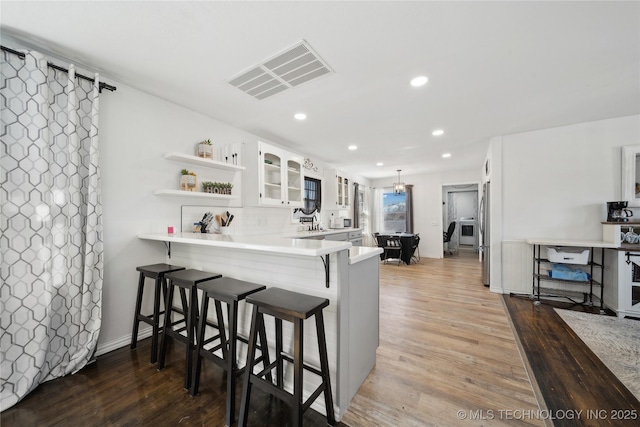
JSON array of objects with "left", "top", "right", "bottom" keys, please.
[{"left": 504, "top": 295, "right": 640, "bottom": 426}]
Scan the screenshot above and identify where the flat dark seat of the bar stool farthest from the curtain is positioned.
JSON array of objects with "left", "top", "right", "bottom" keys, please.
[{"left": 247, "top": 288, "right": 329, "bottom": 319}]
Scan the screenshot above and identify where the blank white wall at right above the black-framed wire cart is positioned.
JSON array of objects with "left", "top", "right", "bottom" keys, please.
[{"left": 490, "top": 115, "right": 640, "bottom": 292}]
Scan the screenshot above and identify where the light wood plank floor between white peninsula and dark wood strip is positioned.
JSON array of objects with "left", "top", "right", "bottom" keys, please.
[{"left": 343, "top": 253, "right": 542, "bottom": 427}]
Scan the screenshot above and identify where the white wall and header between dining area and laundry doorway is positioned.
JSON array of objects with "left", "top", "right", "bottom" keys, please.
[{"left": 371, "top": 170, "right": 481, "bottom": 258}]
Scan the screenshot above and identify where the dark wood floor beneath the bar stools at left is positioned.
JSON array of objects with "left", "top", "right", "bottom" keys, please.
[{"left": 0, "top": 339, "right": 344, "bottom": 427}]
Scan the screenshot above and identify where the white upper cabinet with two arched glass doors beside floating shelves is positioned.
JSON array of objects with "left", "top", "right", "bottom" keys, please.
[{"left": 243, "top": 141, "right": 304, "bottom": 208}]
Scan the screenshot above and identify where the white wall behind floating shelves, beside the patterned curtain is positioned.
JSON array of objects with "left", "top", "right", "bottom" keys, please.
[{"left": 98, "top": 80, "right": 368, "bottom": 354}]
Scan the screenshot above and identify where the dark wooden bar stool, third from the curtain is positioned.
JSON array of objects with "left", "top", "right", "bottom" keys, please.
[{"left": 191, "top": 277, "right": 269, "bottom": 426}]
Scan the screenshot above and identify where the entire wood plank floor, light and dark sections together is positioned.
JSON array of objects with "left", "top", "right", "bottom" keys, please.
[{"left": 7, "top": 253, "right": 640, "bottom": 427}]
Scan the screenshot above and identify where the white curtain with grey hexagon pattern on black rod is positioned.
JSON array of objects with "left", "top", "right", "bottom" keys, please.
[{"left": 0, "top": 52, "right": 103, "bottom": 410}]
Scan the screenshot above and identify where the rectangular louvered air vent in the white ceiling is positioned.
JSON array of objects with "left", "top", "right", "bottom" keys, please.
[{"left": 227, "top": 40, "right": 333, "bottom": 99}]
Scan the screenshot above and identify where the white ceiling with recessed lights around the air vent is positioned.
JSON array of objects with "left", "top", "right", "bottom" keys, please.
[{"left": 0, "top": 0, "right": 640, "bottom": 178}]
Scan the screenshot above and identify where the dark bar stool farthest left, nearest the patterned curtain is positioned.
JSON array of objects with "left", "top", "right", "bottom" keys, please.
[{"left": 131, "top": 264, "right": 184, "bottom": 363}]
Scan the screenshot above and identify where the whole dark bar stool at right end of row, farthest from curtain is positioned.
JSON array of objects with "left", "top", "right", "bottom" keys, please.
[{"left": 238, "top": 288, "right": 336, "bottom": 426}]
